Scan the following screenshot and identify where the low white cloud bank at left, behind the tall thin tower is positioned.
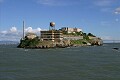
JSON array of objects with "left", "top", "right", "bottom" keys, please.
[{"left": 0, "top": 27, "right": 41, "bottom": 41}]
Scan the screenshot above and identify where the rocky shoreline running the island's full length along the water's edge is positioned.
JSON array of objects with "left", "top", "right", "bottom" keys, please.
[{"left": 17, "top": 39, "right": 103, "bottom": 49}]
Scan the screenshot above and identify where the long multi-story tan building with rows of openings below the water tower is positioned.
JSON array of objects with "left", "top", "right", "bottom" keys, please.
[{"left": 41, "top": 30, "right": 63, "bottom": 41}]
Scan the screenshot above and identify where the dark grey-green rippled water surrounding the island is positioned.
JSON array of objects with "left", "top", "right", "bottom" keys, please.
[{"left": 0, "top": 43, "right": 120, "bottom": 80}]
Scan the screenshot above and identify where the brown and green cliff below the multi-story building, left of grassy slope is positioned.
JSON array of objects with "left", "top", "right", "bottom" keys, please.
[{"left": 18, "top": 38, "right": 71, "bottom": 49}]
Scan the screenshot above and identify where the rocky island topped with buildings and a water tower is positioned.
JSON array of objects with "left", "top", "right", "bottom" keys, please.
[{"left": 17, "top": 22, "right": 103, "bottom": 49}]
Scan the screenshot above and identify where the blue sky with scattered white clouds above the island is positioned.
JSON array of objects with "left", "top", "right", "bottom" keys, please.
[{"left": 0, "top": 0, "right": 120, "bottom": 40}]
